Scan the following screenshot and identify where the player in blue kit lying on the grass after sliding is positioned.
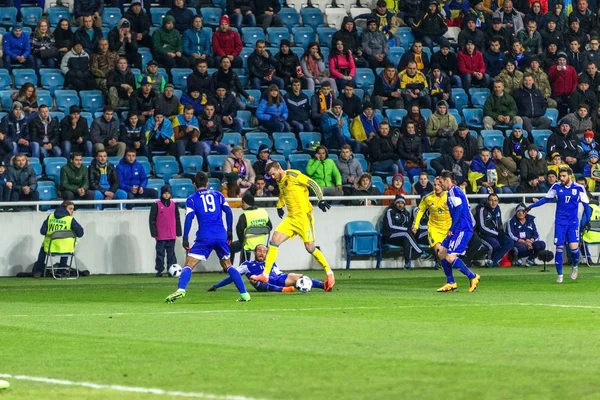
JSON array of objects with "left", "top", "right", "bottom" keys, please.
[{"left": 208, "top": 244, "right": 325, "bottom": 293}]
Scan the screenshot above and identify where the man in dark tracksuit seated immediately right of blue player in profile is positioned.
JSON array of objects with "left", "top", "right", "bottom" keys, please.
[{"left": 475, "top": 194, "right": 514, "bottom": 267}]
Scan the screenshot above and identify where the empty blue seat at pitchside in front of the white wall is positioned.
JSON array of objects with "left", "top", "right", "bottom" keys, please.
[{"left": 344, "top": 221, "right": 381, "bottom": 269}]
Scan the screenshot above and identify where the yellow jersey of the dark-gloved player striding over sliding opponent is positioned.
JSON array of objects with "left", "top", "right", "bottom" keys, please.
[{"left": 277, "top": 169, "right": 323, "bottom": 217}]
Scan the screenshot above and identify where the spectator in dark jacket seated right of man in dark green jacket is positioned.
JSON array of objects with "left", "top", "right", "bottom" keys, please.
[{"left": 514, "top": 74, "right": 552, "bottom": 132}]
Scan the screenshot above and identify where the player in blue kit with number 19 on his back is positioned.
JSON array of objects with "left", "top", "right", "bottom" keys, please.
[{"left": 165, "top": 172, "right": 250, "bottom": 303}]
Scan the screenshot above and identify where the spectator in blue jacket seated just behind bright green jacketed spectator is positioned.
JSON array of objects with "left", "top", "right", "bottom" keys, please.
[{"left": 321, "top": 100, "right": 367, "bottom": 154}]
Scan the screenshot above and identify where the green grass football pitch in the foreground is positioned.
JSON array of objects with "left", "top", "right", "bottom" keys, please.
[{"left": 0, "top": 267, "right": 600, "bottom": 400}]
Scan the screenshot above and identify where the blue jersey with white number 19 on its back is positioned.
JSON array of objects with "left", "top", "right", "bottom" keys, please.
[{"left": 183, "top": 189, "right": 233, "bottom": 241}]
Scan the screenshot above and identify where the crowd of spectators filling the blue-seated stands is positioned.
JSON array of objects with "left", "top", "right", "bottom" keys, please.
[{"left": 0, "top": 0, "right": 600, "bottom": 209}]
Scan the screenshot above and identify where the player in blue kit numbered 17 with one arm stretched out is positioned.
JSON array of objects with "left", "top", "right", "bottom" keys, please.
[{"left": 526, "top": 167, "right": 592, "bottom": 283}]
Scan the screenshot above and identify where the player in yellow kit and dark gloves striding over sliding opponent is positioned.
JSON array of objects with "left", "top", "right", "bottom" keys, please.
[{"left": 250, "top": 161, "right": 335, "bottom": 292}]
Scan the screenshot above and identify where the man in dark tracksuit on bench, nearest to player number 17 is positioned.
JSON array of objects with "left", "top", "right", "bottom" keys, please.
[{"left": 508, "top": 203, "right": 546, "bottom": 267}]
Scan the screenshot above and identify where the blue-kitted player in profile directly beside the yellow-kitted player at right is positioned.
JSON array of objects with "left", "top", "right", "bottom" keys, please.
[{"left": 437, "top": 171, "right": 481, "bottom": 293}]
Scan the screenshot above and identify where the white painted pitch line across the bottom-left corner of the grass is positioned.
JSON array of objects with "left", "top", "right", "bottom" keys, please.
[{"left": 0, "top": 373, "right": 266, "bottom": 400}]
